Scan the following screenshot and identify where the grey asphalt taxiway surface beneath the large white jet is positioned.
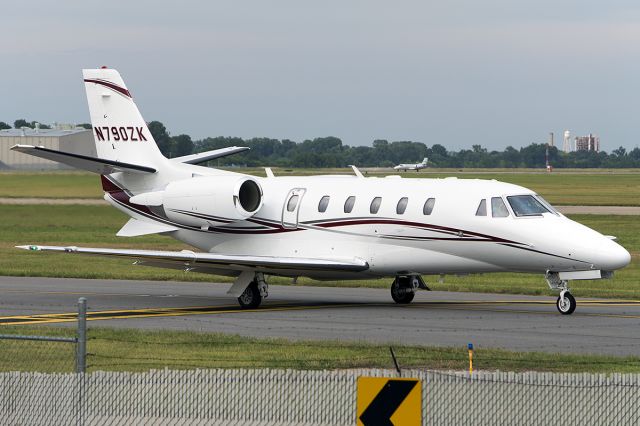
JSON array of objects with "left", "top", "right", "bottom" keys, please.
[{"left": 0, "top": 277, "right": 640, "bottom": 355}]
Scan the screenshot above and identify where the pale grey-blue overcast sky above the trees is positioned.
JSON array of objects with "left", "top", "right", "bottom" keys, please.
[{"left": 0, "top": 0, "right": 640, "bottom": 152}]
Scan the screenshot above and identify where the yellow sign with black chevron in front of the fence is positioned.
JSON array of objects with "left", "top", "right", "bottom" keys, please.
[{"left": 356, "top": 377, "right": 422, "bottom": 426}]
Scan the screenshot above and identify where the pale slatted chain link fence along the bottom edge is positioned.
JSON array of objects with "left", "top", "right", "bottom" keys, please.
[{"left": 0, "top": 369, "right": 640, "bottom": 425}]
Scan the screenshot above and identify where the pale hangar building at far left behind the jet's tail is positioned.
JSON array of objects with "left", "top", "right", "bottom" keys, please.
[{"left": 0, "top": 128, "right": 96, "bottom": 170}]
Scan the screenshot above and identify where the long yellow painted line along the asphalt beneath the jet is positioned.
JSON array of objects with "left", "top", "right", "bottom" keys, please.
[{"left": 0, "top": 299, "right": 640, "bottom": 325}]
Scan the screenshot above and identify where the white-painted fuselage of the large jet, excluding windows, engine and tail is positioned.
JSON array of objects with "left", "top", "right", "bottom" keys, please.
[{"left": 160, "top": 176, "right": 629, "bottom": 279}]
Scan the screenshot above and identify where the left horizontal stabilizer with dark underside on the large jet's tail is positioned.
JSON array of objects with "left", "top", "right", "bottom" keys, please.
[{"left": 11, "top": 145, "right": 156, "bottom": 175}]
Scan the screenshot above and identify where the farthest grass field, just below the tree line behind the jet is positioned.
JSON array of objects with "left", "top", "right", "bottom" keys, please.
[{"left": 0, "top": 168, "right": 640, "bottom": 206}]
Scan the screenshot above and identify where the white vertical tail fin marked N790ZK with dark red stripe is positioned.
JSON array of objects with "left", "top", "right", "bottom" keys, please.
[{"left": 82, "top": 68, "right": 168, "bottom": 170}]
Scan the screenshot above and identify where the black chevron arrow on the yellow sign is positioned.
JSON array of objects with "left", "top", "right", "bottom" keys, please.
[{"left": 360, "top": 379, "right": 418, "bottom": 426}]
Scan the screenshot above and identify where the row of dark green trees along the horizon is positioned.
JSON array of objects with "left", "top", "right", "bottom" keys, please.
[{"left": 5, "top": 119, "right": 640, "bottom": 168}]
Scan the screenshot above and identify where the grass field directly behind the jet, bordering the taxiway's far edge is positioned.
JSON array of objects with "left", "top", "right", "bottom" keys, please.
[{"left": 0, "top": 205, "right": 640, "bottom": 299}]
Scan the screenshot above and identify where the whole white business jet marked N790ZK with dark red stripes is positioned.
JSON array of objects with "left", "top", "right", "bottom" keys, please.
[{"left": 12, "top": 68, "right": 630, "bottom": 314}]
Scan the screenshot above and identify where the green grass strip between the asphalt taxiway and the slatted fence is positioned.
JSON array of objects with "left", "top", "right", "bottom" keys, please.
[{"left": 0, "top": 326, "right": 640, "bottom": 373}]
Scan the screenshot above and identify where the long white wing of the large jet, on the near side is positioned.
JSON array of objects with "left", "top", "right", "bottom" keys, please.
[{"left": 16, "top": 245, "right": 369, "bottom": 275}]
